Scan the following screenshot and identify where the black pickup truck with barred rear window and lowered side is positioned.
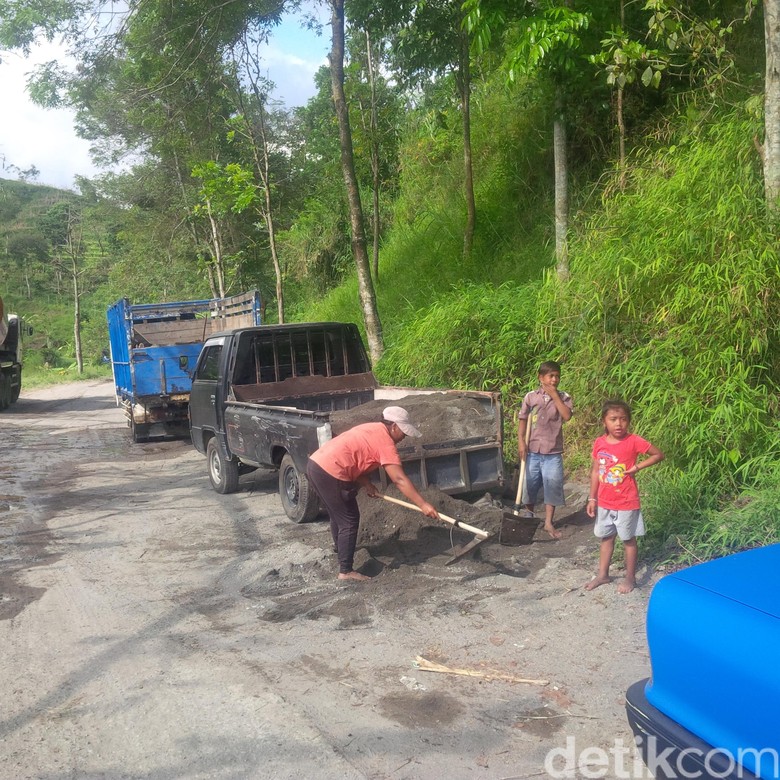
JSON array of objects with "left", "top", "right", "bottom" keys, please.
[{"left": 190, "top": 322, "right": 504, "bottom": 523}]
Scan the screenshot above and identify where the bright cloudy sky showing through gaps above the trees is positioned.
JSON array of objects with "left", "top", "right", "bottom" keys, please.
[{"left": 0, "top": 8, "right": 330, "bottom": 194}]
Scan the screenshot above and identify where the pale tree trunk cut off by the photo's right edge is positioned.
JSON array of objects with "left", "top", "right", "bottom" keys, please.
[{"left": 764, "top": 0, "right": 780, "bottom": 215}]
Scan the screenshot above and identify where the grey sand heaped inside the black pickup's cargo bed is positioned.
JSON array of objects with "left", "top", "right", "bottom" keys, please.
[{"left": 330, "top": 393, "right": 500, "bottom": 453}]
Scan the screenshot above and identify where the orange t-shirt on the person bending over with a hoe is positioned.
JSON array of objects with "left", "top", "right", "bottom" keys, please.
[{"left": 309, "top": 423, "right": 401, "bottom": 482}]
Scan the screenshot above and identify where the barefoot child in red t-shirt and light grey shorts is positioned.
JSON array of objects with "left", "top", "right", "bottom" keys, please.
[{"left": 585, "top": 401, "right": 664, "bottom": 593}]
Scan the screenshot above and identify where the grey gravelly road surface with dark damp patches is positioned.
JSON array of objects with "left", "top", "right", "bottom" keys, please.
[{"left": 0, "top": 382, "right": 652, "bottom": 780}]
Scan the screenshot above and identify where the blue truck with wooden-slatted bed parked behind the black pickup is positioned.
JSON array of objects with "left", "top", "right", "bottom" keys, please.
[{"left": 107, "top": 290, "right": 262, "bottom": 442}]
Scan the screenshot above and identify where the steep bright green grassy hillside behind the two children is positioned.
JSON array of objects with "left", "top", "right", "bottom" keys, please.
[{"left": 302, "top": 85, "right": 780, "bottom": 560}]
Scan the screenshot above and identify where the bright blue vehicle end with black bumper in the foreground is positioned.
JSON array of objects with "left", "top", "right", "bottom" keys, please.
[{"left": 626, "top": 544, "right": 780, "bottom": 780}]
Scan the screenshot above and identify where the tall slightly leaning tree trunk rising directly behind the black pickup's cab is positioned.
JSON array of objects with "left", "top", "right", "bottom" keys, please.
[{"left": 330, "top": 0, "right": 384, "bottom": 363}]
